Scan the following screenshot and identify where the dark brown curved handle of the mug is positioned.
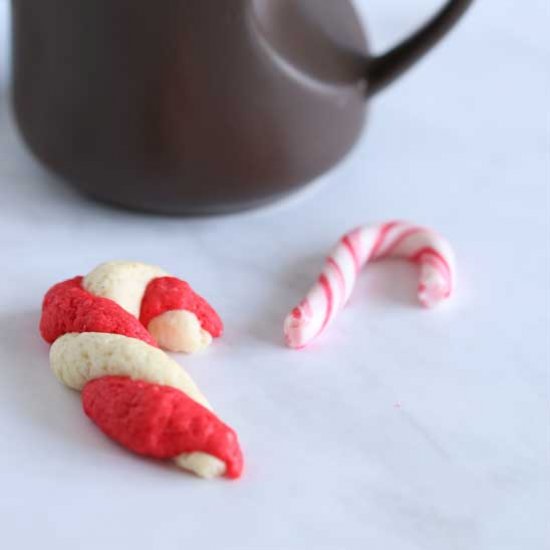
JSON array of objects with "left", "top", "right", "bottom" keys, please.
[{"left": 367, "top": 0, "right": 473, "bottom": 97}]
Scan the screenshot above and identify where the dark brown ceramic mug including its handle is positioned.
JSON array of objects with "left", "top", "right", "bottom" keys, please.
[{"left": 12, "top": 0, "right": 472, "bottom": 214}]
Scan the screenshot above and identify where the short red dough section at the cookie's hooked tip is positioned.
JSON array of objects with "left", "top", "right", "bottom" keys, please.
[{"left": 140, "top": 277, "right": 223, "bottom": 338}]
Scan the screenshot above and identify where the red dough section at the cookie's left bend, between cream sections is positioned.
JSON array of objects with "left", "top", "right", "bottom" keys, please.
[{"left": 40, "top": 276, "right": 157, "bottom": 347}]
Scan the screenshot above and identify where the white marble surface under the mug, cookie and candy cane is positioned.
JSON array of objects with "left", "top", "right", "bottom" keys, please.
[{"left": 0, "top": 0, "right": 550, "bottom": 550}]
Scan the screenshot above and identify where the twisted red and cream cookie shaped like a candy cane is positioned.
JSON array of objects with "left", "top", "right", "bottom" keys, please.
[{"left": 40, "top": 262, "right": 242, "bottom": 478}]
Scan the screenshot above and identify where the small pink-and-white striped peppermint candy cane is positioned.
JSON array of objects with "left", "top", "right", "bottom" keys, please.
[{"left": 284, "top": 222, "right": 455, "bottom": 349}]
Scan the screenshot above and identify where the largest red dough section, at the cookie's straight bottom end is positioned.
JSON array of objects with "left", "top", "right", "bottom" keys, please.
[{"left": 82, "top": 376, "right": 243, "bottom": 478}]
